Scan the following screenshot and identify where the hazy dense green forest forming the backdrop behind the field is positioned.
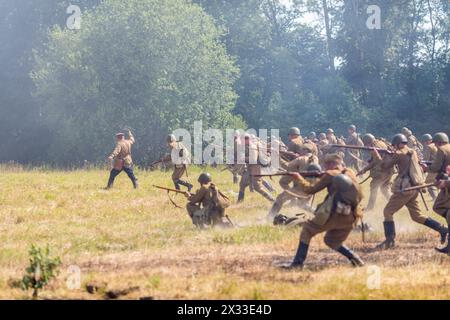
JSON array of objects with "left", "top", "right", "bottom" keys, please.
[{"left": 0, "top": 0, "right": 450, "bottom": 165}]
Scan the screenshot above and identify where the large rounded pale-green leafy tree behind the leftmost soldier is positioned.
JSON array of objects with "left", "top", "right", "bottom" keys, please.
[{"left": 33, "top": 0, "right": 244, "bottom": 164}]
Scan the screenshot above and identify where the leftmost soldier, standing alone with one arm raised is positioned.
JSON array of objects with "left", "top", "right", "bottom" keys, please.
[{"left": 105, "top": 131, "right": 138, "bottom": 190}]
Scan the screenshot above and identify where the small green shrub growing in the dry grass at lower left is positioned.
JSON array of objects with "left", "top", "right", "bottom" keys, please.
[{"left": 22, "top": 245, "right": 61, "bottom": 299}]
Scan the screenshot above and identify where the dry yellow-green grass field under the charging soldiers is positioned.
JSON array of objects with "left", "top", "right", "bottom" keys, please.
[{"left": 0, "top": 167, "right": 450, "bottom": 299}]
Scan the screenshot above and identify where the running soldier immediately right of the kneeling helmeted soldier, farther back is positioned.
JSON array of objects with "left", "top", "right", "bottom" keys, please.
[{"left": 238, "top": 135, "right": 275, "bottom": 202}]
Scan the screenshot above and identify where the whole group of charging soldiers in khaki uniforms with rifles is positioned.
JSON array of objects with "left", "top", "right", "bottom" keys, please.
[{"left": 107, "top": 125, "right": 450, "bottom": 268}]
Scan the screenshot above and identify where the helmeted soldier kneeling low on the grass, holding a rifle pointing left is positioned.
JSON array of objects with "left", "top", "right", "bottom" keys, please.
[{"left": 186, "top": 173, "right": 231, "bottom": 229}]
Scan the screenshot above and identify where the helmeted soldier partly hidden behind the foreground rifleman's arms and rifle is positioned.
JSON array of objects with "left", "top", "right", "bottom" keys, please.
[{"left": 268, "top": 144, "right": 322, "bottom": 220}]
